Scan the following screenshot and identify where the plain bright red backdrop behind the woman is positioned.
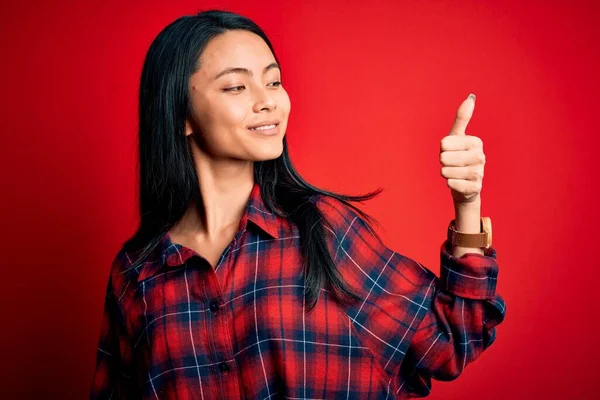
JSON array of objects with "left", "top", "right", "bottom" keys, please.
[{"left": 0, "top": 0, "right": 600, "bottom": 400}]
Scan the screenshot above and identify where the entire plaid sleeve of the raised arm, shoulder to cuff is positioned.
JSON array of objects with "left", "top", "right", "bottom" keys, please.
[{"left": 316, "top": 196, "right": 506, "bottom": 398}]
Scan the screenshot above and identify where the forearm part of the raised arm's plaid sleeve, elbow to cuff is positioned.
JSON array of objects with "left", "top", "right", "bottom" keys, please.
[{"left": 398, "top": 241, "right": 506, "bottom": 397}]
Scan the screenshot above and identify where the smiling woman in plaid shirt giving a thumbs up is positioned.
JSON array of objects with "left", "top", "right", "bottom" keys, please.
[{"left": 90, "top": 10, "right": 505, "bottom": 399}]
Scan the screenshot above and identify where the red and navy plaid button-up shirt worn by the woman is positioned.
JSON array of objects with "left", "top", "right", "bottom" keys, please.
[{"left": 90, "top": 185, "right": 505, "bottom": 399}]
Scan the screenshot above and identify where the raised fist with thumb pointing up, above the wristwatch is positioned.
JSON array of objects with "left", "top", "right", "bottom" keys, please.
[{"left": 440, "top": 94, "right": 485, "bottom": 208}]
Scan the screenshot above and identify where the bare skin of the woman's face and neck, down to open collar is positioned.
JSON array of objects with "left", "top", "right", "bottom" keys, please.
[{"left": 170, "top": 30, "right": 291, "bottom": 267}]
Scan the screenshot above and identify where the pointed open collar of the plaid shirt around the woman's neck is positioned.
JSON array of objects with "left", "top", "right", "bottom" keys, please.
[{"left": 137, "top": 183, "right": 282, "bottom": 282}]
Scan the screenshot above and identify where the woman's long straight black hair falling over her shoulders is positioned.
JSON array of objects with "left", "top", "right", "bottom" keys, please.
[{"left": 124, "top": 10, "right": 382, "bottom": 311}]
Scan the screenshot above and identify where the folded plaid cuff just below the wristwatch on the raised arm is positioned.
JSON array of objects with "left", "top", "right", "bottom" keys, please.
[{"left": 440, "top": 240, "right": 498, "bottom": 300}]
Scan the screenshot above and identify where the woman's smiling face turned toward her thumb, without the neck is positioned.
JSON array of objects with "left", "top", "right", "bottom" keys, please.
[{"left": 186, "top": 30, "right": 291, "bottom": 161}]
